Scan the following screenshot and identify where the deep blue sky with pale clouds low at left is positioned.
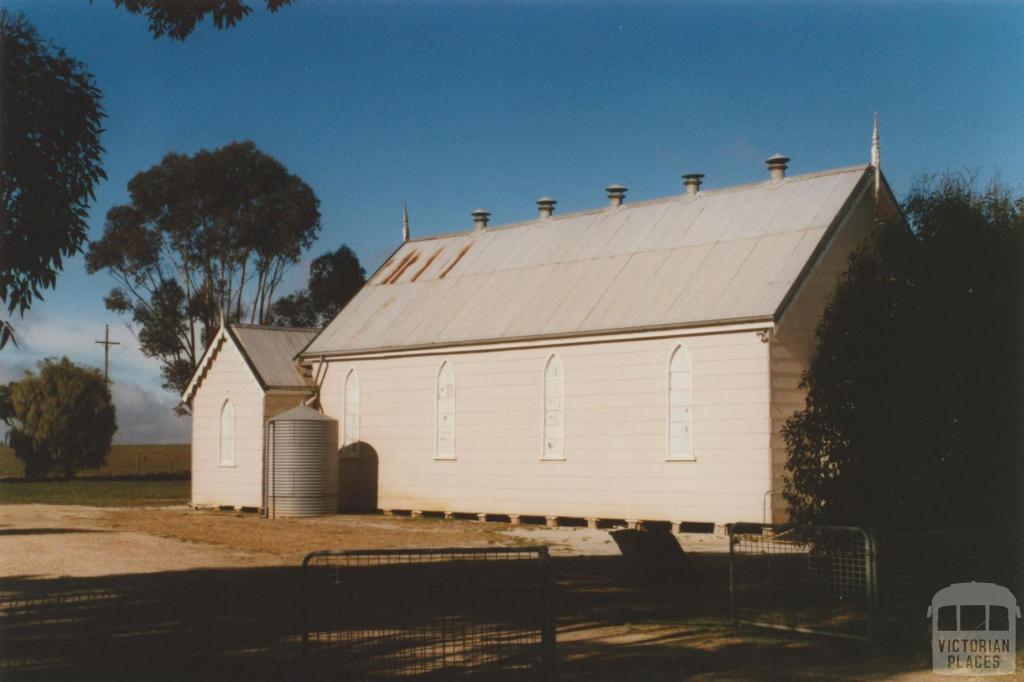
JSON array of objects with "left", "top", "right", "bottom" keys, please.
[{"left": 0, "top": 0, "right": 1024, "bottom": 442}]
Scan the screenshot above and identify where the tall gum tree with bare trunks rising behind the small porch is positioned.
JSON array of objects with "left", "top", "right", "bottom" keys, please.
[{"left": 86, "top": 141, "right": 319, "bottom": 392}]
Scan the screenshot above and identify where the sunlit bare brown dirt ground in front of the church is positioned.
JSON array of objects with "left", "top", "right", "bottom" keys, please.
[{"left": 0, "top": 505, "right": 728, "bottom": 578}]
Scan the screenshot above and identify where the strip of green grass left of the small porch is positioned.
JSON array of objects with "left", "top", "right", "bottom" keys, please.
[{"left": 0, "top": 479, "right": 190, "bottom": 507}]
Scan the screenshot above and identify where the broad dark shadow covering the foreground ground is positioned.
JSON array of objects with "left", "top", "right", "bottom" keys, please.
[{"left": 0, "top": 554, "right": 927, "bottom": 681}]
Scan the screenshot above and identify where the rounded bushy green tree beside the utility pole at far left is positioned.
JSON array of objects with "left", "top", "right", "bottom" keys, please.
[{"left": 8, "top": 357, "right": 117, "bottom": 478}]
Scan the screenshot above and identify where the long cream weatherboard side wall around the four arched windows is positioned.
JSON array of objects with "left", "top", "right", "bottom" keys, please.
[{"left": 321, "top": 331, "right": 771, "bottom": 522}]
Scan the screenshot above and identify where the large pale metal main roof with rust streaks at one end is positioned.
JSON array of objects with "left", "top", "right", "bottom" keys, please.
[{"left": 305, "top": 166, "right": 868, "bottom": 355}]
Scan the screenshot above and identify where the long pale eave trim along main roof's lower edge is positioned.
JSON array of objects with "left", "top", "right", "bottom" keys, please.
[{"left": 301, "top": 316, "right": 775, "bottom": 365}]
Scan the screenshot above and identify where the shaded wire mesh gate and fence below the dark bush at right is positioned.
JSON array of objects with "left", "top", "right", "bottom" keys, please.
[{"left": 729, "top": 523, "right": 1024, "bottom": 640}]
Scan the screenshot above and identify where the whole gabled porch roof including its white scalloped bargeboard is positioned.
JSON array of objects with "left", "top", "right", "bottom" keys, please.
[{"left": 181, "top": 325, "right": 319, "bottom": 403}]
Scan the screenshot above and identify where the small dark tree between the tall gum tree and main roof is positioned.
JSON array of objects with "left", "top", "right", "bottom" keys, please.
[{"left": 267, "top": 244, "right": 367, "bottom": 327}]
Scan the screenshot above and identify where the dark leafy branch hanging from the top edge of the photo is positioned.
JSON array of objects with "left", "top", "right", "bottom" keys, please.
[{"left": 114, "top": 0, "right": 294, "bottom": 40}]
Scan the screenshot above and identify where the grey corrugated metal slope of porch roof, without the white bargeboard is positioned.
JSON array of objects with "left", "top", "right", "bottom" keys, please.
[{"left": 229, "top": 325, "right": 319, "bottom": 388}]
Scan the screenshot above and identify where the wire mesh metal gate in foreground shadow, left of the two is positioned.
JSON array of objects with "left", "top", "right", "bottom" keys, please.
[{"left": 303, "top": 547, "right": 555, "bottom": 680}]
